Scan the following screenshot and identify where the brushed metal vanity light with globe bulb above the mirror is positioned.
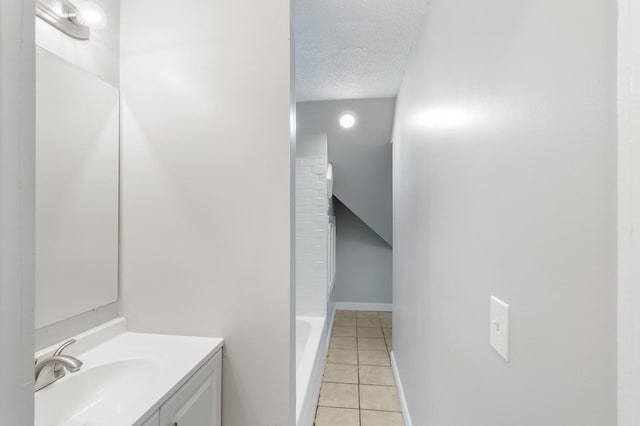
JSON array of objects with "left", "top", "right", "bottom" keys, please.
[{"left": 36, "top": 0, "right": 107, "bottom": 40}]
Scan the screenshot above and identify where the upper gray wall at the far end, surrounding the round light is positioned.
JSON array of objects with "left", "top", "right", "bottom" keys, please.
[{"left": 297, "top": 98, "right": 395, "bottom": 244}]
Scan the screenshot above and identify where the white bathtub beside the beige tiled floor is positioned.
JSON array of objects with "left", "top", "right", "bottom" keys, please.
[{"left": 296, "top": 317, "right": 328, "bottom": 426}]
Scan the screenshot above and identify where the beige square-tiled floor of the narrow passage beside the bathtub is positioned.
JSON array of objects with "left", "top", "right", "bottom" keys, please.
[{"left": 315, "top": 311, "right": 404, "bottom": 426}]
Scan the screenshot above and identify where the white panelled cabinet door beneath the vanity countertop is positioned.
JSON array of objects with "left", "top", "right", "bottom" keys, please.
[{"left": 160, "top": 352, "right": 222, "bottom": 426}]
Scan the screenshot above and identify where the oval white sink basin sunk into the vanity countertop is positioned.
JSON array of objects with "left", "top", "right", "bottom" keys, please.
[{"left": 35, "top": 359, "right": 160, "bottom": 425}]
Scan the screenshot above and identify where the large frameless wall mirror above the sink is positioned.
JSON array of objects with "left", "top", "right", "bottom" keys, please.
[{"left": 36, "top": 48, "right": 119, "bottom": 328}]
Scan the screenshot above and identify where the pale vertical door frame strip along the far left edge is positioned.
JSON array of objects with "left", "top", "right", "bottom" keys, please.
[{"left": 0, "top": 0, "right": 35, "bottom": 426}]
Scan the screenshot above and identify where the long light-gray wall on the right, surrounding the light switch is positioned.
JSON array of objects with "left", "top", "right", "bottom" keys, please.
[{"left": 393, "top": 0, "right": 616, "bottom": 426}]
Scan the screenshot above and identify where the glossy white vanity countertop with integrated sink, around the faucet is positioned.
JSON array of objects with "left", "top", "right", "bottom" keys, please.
[{"left": 35, "top": 319, "right": 222, "bottom": 426}]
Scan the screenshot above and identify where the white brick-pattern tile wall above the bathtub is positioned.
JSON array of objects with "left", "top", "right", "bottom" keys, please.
[{"left": 296, "top": 157, "right": 329, "bottom": 316}]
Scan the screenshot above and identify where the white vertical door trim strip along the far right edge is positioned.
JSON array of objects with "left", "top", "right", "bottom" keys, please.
[{"left": 618, "top": 0, "right": 640, "bottom": 426}]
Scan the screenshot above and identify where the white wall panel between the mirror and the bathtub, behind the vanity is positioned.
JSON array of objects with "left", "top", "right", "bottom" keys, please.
[{"left": 120, "top": 0, "right": 295, "bottom": 426}]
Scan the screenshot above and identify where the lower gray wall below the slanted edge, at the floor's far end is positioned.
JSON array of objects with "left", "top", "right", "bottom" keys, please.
[{"left": 334, "top": 198, "right": 392, "bottom": 303}]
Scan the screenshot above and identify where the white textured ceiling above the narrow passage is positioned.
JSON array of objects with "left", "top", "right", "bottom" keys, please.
[{"left": 295, "top": 0, "right": 427, "bottom": 101}]
